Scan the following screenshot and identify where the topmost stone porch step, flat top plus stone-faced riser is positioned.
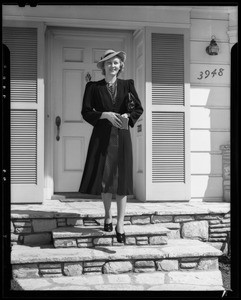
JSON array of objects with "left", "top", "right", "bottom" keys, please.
[{"left": 11, "top": 200, "right": 230, "bottom": 253}]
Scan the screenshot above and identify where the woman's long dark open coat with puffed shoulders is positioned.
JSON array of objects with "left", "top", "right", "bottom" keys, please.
[{"left": 79, "top": 78, "right": 143, "bottom": 195}]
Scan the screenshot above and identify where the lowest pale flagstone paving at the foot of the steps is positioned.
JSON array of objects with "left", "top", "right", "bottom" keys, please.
[{"left": 16, "top": 271, "right": 224, "bottom": 291}]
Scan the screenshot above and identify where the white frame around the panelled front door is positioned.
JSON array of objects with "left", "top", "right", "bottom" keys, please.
[{"left": 44, "top": 26, "right": 135, "bottom": 199}]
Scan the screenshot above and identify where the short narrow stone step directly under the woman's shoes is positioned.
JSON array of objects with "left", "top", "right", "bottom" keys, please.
[{"left": 52, "top": 224, "right": 170, "bottom": 248}]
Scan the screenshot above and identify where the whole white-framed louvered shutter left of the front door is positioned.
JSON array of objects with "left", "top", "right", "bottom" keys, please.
[{"left": 3, "top": 26, "right": 44, "bottom": 203}]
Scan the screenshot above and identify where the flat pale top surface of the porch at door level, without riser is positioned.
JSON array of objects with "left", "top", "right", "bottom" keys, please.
[{"left": 11, "top": 199, "right": 230, "bottom": 218}]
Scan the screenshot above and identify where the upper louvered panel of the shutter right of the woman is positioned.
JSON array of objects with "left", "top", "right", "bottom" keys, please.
[{"left": 152, "top": 33, "right": 184, "bottom": 105}]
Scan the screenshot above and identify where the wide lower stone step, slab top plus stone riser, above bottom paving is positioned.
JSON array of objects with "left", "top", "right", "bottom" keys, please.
[{"left": 11, "top": 239, "right": 222, "bottom": 278}]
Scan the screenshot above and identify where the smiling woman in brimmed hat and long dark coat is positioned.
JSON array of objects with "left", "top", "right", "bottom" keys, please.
[{"left": 79, "top": 50, "right": 143, "bottom": 243}]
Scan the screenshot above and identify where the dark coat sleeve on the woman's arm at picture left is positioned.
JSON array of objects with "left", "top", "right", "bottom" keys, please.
[{"left": 81, "top": 81, "right": 102, "bottom": 126}]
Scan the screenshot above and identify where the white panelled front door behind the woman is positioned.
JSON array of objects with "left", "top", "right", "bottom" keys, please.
[{"left": 51, "top": 29, "right": 130, "bottom": 192}]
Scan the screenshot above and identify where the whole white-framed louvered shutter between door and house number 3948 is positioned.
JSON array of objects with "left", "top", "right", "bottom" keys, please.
[{"left": 146, "top": 28, "right": 190, "bottom": 201}]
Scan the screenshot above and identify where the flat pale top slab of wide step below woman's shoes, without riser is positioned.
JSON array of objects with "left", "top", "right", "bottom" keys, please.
[{"left": 11, "top": 239, "right": 222, "bottom": 264}]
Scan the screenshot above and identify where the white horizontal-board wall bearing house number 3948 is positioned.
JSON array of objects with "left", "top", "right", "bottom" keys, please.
[{"left": 190, "top": 10, "right": 233, "bottom": 201}]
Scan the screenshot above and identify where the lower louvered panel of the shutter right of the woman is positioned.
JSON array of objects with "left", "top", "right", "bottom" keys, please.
[{"left": 152, "top": 112, "right": 185, "bottom": 183}]
